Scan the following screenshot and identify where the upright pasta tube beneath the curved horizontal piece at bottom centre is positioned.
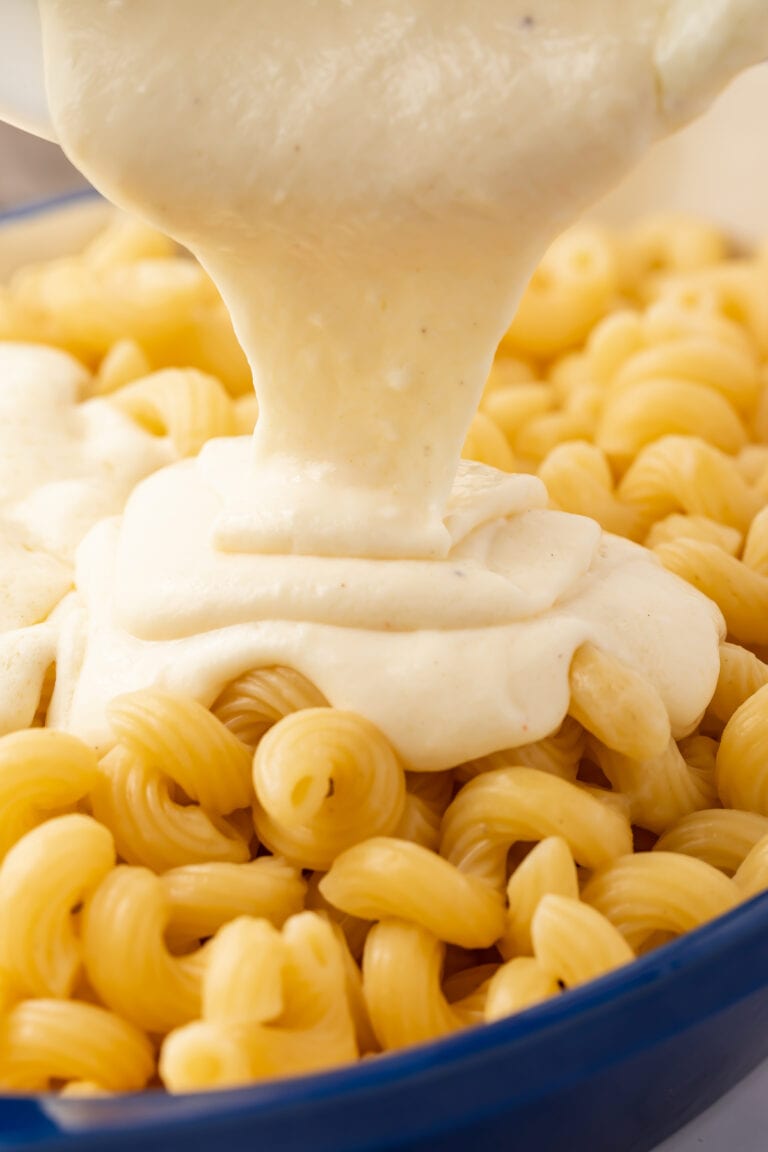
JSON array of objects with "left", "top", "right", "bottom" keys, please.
[{"left": 363, "top": 919, "right": 463, "bottom": 1052}]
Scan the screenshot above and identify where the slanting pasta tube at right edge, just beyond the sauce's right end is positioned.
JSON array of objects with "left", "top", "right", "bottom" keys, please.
[{"left": 655, "top": 539, "right": 768, "bottom": 646}]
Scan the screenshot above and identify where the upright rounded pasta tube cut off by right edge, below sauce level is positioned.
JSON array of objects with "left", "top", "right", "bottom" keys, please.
[{"left": 716, "top": 685, "right": 768, "bottom": 816}]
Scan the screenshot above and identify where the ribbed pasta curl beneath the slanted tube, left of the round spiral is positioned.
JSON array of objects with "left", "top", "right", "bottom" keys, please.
[{"left": 92, "top": 746, "right": 251, "bottom": 872}]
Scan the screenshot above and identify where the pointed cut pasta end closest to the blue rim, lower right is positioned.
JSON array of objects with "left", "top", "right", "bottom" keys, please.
[{"left": 531, "top": 893, "right": 634, "bottom": 988}]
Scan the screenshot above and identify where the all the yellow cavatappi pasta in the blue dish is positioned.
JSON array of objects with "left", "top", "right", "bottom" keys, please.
[{"left": 6, "top": 217, "right": 768, "bottom": 1096}]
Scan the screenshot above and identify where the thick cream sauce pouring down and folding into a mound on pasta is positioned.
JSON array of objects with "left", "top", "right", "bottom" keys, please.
[{"left": 10, "top": 0, "right": 768, "bottom": 768}]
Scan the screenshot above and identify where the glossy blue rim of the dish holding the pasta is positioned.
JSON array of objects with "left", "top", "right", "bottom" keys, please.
[{"left": 0, "top": 188, "right": 768, "bottom": 1133}]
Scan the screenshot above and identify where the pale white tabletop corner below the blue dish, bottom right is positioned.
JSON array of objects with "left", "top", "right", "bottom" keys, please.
[{"left": 656, "top": 1061, "right": 768, "bottom": 1152}]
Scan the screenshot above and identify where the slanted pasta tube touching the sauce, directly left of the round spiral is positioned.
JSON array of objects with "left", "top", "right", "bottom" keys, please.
[{"left": 107, "top": 689, "right": 252, "bottom": 813}]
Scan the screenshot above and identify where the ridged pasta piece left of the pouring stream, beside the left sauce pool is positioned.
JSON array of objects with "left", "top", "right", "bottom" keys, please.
[{"left": 108, "top": 367, "right": 237, "bottom": 456}]
